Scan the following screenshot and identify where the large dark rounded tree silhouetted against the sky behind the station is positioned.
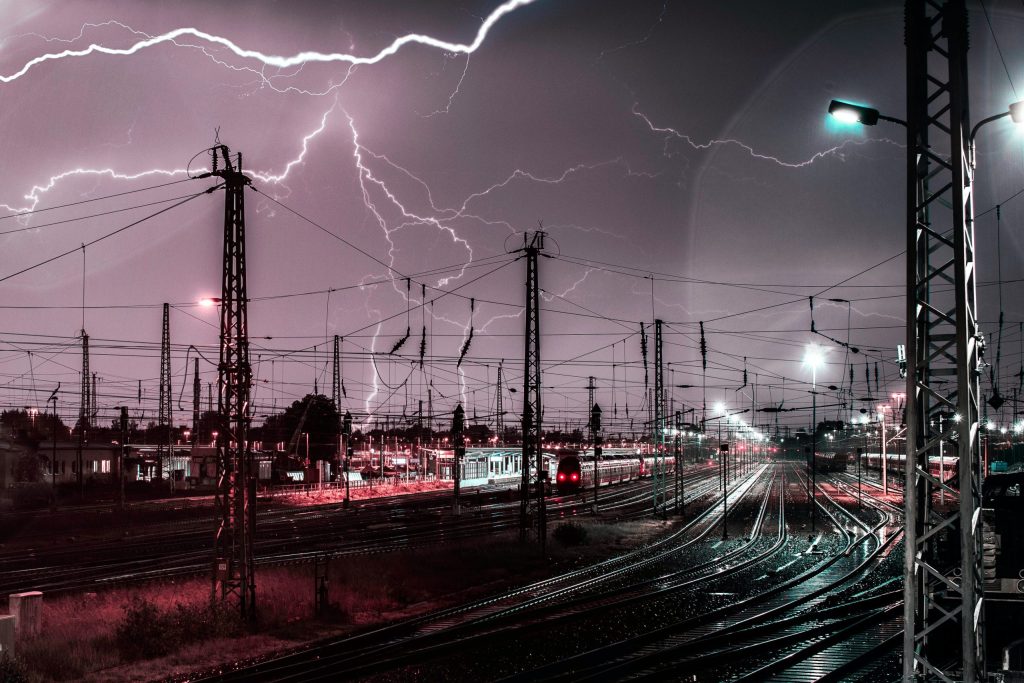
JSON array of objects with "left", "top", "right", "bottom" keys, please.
[{"left": 252, "top": 394, "right": 341, "bottom": 460}]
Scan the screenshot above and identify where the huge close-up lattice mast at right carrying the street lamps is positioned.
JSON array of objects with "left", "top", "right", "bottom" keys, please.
[{"left": 903, "top": 0, "right": 985, "bottom": 681}]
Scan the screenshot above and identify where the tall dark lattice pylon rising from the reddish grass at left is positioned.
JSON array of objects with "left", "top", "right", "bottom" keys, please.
[{"left": 199, "top": 144, "right": 256, "bottom": 620}]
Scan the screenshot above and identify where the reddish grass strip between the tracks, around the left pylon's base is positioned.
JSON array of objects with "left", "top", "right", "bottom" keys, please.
[{"left": 8, "top": 511, "right": 665, "bottom": 683}]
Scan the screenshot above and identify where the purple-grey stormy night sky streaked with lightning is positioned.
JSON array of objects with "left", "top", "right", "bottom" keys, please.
[{"left": 0, "top": 0, "right": 1024, "bottom": 432}]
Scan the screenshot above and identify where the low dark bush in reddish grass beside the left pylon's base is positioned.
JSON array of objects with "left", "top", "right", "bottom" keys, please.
[{"left": 115, "top": 597, "right": 242, "bottom": 661}]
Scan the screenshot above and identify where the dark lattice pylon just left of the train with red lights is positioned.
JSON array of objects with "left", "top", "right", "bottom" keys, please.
[{"left": 519, "top": 230, "right": 548, "bottom": 546}]
